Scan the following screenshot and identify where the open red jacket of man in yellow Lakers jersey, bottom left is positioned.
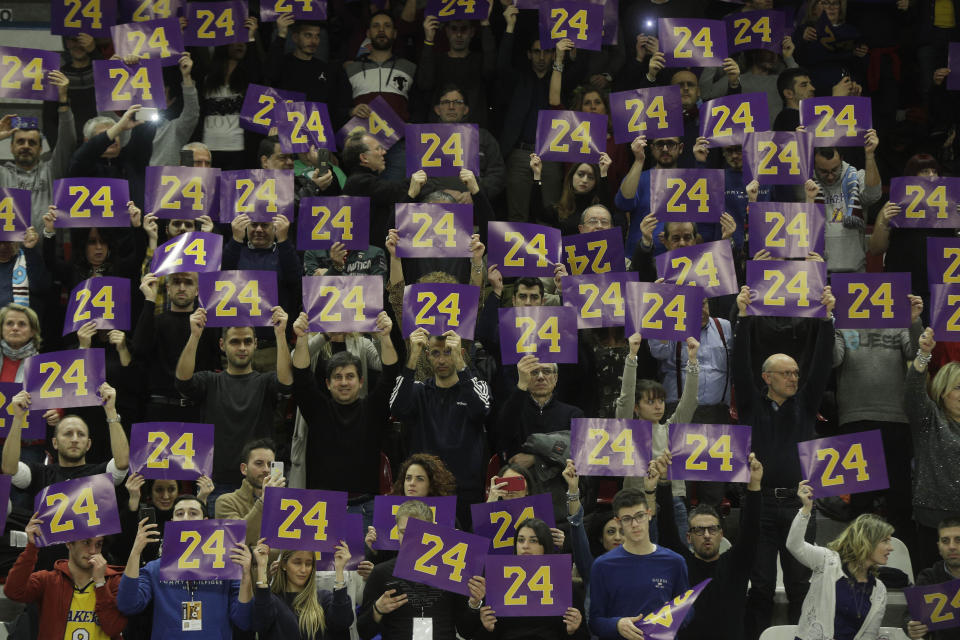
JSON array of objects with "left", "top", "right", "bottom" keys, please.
[{"left": 3, "top": 542, "right": 127, "bottom": 640}]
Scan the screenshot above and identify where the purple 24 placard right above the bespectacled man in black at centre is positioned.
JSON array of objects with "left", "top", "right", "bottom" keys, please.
[{"left": 499, "top": 307, "right": 577, "bottom": 364}]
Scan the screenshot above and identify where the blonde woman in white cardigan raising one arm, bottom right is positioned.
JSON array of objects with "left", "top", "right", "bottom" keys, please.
[{"left": 787, "top": 480, "right": 893, "bottom": 640}]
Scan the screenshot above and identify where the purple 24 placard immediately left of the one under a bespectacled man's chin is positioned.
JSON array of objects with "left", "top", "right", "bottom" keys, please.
[{"left": 487, "top": 222, "right": 562, "bottom": 278}]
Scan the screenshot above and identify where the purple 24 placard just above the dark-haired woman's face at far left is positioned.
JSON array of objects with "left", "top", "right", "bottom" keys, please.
[{"left": 53, "top": 178, "right": 130, "bottom": 229}]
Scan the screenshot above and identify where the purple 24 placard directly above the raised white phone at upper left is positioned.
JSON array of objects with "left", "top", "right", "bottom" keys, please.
[{"left": 93, "top": 60, "right": 167, "bottom": 111}]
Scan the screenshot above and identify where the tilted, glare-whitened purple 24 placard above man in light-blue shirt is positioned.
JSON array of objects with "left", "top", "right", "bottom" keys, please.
[{"left": 657, "top": 240, "right": 740, "bottom": 298}]
